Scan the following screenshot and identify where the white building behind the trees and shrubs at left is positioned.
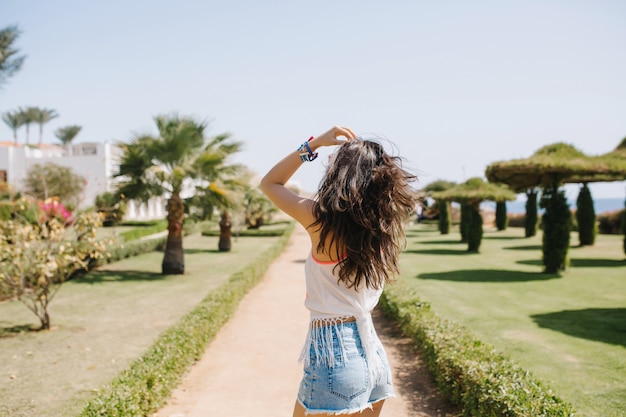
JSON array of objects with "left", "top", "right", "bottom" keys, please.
[{"left": 0, "top": 142, "right": 165, "bottom": 220}]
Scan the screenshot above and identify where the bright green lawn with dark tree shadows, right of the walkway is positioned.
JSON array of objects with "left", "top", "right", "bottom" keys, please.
[{"left": 401, "top": 225, "right": 626, "bottom": 417}]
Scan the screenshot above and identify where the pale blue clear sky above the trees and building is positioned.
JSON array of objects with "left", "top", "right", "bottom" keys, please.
[{"left": 0, "top": 0, "right": 626, "bottom": 202}]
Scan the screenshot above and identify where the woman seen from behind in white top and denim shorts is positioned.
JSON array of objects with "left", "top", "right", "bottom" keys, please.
[{"left": 261, "top": 127, "right": 415, "bottom": 417}]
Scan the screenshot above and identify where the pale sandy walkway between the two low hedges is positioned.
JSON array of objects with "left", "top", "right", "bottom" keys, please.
[{"left": 154, "top": 227, "right": 458, "bottom": 417}]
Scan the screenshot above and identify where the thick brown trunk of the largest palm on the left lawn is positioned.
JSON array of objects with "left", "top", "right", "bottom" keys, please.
[{"left": 161, "top": 193, "right": 185, "bottom": 275}]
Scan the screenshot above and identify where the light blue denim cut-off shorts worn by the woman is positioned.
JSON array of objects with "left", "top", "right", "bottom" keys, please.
[{"left": 298, "top": 322, "right": 395, "bottom": 414}]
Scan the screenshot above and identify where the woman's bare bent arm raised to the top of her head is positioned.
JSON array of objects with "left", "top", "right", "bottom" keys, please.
[{"left": 261, "top": 126, "right": 356, "bottom": 227}]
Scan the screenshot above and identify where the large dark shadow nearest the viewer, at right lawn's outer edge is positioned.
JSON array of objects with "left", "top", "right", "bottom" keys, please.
[{"left": 530, "top": 308, "right": 626, "bottom": 347}]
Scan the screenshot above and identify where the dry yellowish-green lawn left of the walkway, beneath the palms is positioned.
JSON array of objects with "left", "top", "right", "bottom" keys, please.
[{"left": 0, "top": 234, "right": 279, "bottom": 417}]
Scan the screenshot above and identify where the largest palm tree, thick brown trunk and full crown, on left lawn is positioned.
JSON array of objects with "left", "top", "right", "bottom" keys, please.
[{"left": 115, "top": 114, "right": 241, "bottom": 274}]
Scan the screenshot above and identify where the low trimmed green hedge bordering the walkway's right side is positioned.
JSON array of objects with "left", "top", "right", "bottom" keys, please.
[{"left": 380, "top": 281, "right": 574, "bottom": 417}]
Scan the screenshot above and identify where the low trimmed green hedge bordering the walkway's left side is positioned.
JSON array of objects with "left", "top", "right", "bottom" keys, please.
[{"left": 80, "top": 224, "right": 294, "bottom": 417}]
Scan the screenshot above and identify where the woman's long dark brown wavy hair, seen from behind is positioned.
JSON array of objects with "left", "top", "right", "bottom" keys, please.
[{"left": 311, "top": 139, "right": 417, "bottom": 289}]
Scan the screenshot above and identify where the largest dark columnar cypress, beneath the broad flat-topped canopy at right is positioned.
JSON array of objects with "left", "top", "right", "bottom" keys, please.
[{"left": 540, "top": 182, "right": 572, "bottom": 274}]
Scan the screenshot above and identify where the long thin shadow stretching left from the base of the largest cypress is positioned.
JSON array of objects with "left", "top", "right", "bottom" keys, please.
[{"left": 417, "top": 269, "right": 560, "bottom": 282}]
